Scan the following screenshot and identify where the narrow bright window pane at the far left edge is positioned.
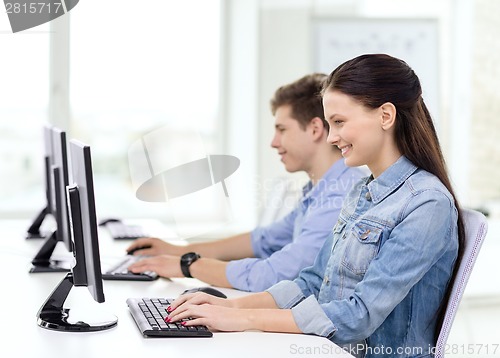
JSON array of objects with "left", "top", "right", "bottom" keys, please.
[{"left": 0, "top": 21, "right": 50, "bottom": 218}]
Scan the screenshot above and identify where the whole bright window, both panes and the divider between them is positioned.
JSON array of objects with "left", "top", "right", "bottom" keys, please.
[{"left": 0, "top": 0, "right": 225, "bottom": 232}]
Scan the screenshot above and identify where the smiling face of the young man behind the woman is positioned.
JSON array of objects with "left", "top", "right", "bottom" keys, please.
[{"left": 271, "top": 105, "right": 314, "bottom": 173}]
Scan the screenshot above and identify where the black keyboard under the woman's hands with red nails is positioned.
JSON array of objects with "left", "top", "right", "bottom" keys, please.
[{"left": 127, "top": 298, "right": 212, "bottom": 337}]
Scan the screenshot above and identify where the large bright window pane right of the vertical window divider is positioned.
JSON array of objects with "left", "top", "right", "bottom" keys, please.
[{"left": 69, "top": 0, "right": 220, "bottom": 227}]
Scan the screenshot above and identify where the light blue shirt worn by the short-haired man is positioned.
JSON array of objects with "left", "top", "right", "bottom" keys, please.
[{"left": 226, "top": 159, "right": 363, "bottom": 292}]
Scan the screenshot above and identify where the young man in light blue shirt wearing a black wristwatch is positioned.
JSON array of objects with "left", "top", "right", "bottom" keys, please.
[{"left": 128, "top": 74, "right": 362, "bottom": 292}]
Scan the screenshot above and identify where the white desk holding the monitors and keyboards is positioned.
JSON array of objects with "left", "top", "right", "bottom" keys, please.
[{"left": 0, "top": 221, "right": 351, "bottom": 358}]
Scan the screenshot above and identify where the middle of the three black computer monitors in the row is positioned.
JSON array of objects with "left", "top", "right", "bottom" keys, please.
[{"left": 30, "top": 127, "right": 72, "bottom": 273}]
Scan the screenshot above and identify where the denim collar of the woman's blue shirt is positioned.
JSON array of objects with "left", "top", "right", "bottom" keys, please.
[{"left": 366, "top": 156, "right": 418, "bottom": 204}]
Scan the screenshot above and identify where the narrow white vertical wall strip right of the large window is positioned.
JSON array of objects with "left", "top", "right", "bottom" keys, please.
[{"left": 220, "top": 0, "right": 259, "bottom": 229}]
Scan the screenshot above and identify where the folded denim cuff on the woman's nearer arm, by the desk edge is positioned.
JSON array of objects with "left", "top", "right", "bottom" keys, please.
[{"left": 292, "top": 295, "right": 337, "bottom": 338}]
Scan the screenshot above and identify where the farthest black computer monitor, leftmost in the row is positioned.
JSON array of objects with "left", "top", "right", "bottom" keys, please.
[{"left": 26, "top": 124, "right": 54, "bottom": 239}]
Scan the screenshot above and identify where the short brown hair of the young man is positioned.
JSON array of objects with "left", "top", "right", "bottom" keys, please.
[{"left": 271, "top": 73, "right": 329, "bottom": 130}]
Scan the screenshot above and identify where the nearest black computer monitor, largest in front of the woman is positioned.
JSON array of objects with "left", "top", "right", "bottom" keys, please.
[{"left": 38, "top": 140, "right": 117, "bottom": 332}]
